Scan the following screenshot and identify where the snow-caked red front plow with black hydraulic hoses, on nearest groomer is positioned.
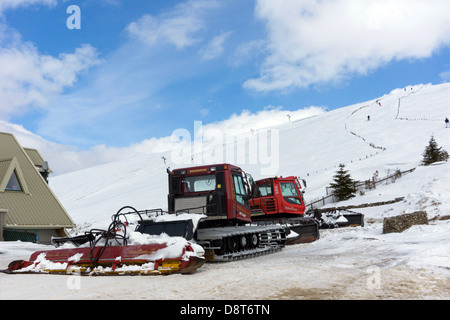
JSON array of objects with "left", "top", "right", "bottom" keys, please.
[{"left": 2, "top": 207, "right": 205, "bottom": 275}]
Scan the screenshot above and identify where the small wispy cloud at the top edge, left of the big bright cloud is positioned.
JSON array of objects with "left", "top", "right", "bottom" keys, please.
[{"left": 127, "top": 0, "right": 218, "bottom": 49}]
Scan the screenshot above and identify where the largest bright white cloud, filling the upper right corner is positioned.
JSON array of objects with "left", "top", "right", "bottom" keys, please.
[{"left": 245, "top": 0, "right": 450, "bottom": 91}]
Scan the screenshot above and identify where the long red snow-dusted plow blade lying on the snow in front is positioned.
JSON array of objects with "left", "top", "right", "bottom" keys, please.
[{"left": 5, "top": 244, "right": 205, "bottom": 275}]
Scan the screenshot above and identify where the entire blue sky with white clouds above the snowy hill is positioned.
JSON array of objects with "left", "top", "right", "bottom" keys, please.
[{"left": 0, "top": 0, "right": 450, "bottom": 170}]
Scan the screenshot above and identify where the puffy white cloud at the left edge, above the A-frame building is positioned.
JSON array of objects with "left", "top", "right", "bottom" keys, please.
[{"left": 0, "top": 25, "right": 99, "bottom": 118}]
